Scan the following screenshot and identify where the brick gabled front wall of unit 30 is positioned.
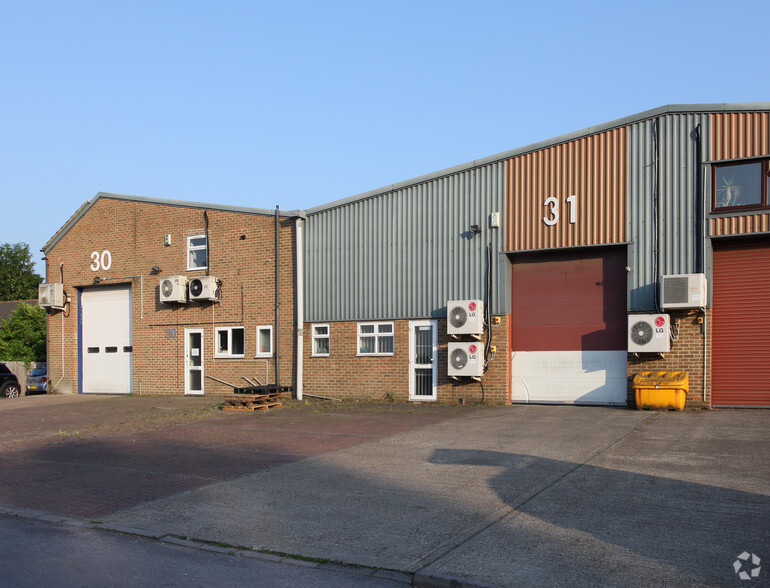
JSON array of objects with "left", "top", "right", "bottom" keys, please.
[{"left": 46, "top": 198, "right": 296, "bottom": 394}]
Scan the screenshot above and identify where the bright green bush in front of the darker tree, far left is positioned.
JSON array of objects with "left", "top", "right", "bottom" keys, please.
[{"left": 0, "top": 302, "right": 46, "bottom": 361}]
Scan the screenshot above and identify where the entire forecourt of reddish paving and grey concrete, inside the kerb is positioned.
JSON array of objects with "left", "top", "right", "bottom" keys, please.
[{"left": 0, "top": 397, "right": 770, "bottom": 586}]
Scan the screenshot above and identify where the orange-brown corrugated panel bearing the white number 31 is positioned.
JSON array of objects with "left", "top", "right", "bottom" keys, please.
[{"left": 505, "top": 127, "right": 627, "bottom": 252}]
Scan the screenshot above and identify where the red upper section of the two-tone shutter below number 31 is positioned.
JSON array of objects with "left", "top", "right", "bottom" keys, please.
[{"left": 511, "top": 247, "right": 627, "bottom": 351}]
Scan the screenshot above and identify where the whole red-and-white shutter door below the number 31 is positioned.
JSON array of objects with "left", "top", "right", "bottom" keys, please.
[{"left": 511, "top": 247, "right": 627, "bottom": 405}]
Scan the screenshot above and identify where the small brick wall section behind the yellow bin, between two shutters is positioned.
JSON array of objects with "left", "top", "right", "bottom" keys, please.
[{"left": 628, "top": 310, "right": 711, "bottom": 408}]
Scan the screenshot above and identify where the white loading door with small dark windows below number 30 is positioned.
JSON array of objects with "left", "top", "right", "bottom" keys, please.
[{"left": 80, "top": 286, "right": 133, "bottom": 394}]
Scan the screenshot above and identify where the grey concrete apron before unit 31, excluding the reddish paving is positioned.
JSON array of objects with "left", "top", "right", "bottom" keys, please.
[{"left": 104, "top": 406, "right": 770, "bottom": 586}]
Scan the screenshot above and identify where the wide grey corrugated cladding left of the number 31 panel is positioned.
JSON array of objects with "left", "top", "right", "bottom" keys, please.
[{"left": 305, "top": 162, "right": 510, "bottom": 322}]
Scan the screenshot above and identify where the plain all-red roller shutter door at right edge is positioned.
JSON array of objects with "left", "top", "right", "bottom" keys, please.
[{"left": 711, "top": 238, "right": 770, "bottom": 406}]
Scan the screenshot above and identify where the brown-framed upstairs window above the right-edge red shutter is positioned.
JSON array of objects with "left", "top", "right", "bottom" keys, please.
[{"left": 712, "top": 159, "right": 770, "bottom": 212}]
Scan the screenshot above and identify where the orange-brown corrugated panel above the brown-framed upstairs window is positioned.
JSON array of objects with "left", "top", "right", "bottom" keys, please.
[{"left": 711, "top": 112, "right": 770, "bottom": 161}]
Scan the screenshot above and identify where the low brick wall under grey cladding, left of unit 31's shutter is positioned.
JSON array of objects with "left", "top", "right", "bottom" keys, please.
[{"left": 303, "top": 316, "right": 511, "bottom": 404}]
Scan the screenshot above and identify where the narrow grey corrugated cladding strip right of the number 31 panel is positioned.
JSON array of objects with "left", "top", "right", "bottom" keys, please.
[{"left": 628, "top": 113, "right": 711, "bottom": 311}]
